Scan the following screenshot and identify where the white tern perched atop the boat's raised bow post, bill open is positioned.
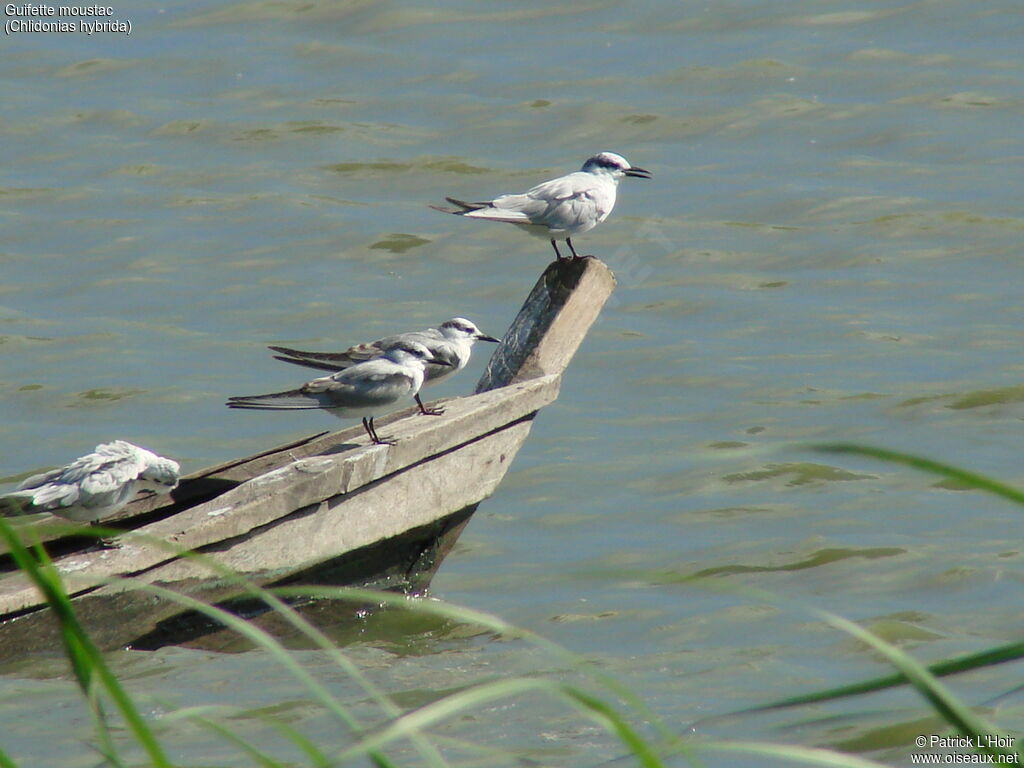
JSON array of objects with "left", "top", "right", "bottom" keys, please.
[{"left": 431, "top": 152, "right": 651, "bottom": 259}]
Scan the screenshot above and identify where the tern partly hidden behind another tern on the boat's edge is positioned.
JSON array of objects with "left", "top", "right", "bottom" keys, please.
[{"left": 270, "top": 317, "right": 500, "bottom": 416}]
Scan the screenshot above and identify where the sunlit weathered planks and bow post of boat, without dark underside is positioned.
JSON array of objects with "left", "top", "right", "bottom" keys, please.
[{"left": 0, "top": 259, "right": 614, "bottom": 656}]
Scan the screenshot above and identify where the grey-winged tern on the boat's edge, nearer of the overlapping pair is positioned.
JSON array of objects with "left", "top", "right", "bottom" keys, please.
[{"left": 227, "top": 341, "right": 452, "bottom": 445}]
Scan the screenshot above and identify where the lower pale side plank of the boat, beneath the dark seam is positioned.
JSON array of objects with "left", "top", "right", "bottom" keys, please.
[{"left": 0, "top": 420, "right": 531, "bottom": 660}]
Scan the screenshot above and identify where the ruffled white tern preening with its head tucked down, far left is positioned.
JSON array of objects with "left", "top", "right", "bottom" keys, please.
[{"left": 0, "top": 440, "right": 180, "bottom": 522}]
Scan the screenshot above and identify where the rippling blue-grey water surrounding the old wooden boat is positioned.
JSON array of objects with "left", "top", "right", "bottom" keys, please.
[{"left": 0, "top": 0, "right": 1024, "bottom": 766}]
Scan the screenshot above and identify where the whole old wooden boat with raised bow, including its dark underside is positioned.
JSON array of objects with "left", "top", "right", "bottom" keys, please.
[{"left": 0, "top": 258, "right": 614, "bottom": 658}]
